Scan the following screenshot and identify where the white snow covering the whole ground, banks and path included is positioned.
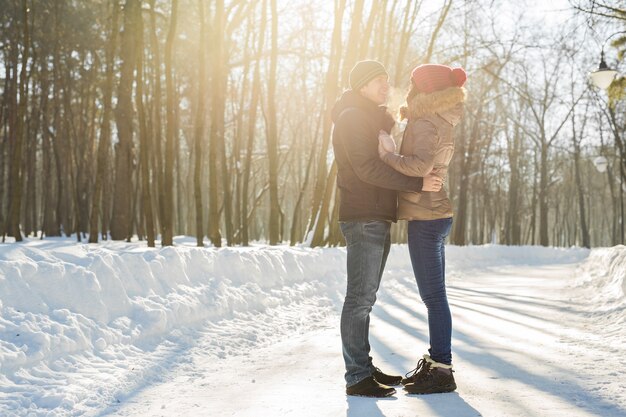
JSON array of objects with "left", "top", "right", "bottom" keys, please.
[{"left": 0, "top": 237, "right": 626, "bottom": 417}]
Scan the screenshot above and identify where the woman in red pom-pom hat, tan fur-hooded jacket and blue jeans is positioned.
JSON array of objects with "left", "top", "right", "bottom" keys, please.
[{"left": 379, "top": 64, "right": 467, "bottom": 394}]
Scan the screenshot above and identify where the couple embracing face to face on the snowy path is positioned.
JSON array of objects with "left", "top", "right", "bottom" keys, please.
[{"left": 332, "top": 61, "right": 467, "bottom": 397}]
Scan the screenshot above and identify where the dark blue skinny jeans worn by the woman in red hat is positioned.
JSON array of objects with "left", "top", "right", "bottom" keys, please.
[{"left": 408, "top": 217, "right": 452, "bottom": 365}]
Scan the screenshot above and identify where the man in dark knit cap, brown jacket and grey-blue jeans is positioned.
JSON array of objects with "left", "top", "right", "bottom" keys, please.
[{"left": 332, "top": 61, "right": 441, "bottom": 397}]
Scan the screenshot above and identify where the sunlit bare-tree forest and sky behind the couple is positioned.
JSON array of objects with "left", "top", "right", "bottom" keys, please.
[{"left": 0, "top": 0, "right": 626, "bottom": 247}]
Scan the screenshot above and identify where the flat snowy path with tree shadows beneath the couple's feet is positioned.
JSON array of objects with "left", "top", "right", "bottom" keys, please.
[{"left": 99, "top": 263, "right": 626, "bottom": 417}]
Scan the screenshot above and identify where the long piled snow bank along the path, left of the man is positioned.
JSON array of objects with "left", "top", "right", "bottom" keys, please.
[{"left": 0, "top": 240, "right": 344, "bottom": 373}]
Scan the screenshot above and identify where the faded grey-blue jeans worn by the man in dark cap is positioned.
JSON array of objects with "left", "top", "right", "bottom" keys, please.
[{"left": 340, "top": 221, "right": 391, "bottom": 387}]
